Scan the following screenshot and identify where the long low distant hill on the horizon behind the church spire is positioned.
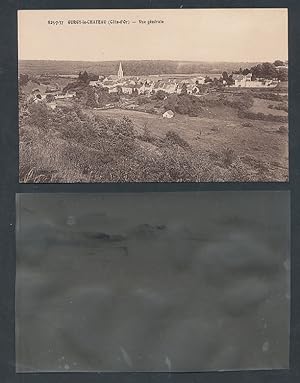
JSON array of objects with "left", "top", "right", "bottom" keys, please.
[{"left": 19, "top": 60, "right": 258, "bottom": 76}]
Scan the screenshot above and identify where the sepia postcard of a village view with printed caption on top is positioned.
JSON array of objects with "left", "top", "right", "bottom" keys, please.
[{"left": 18, "top": 8, "right": 289, "bottom": 183}]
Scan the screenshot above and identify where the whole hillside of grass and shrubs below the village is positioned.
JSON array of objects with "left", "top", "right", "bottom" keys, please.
[{"left": 20, "top": 85, "right": 288, "bottom": 183}]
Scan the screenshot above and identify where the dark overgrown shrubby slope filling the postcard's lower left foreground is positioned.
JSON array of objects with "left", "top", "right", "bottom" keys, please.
[{"left": 19, "top": 102, "right": 284, "bottom": 183}]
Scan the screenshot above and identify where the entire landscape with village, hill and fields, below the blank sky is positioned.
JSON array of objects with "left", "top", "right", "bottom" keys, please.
[{"left": 19, "top": 60, "right": 288, "bottom": 183}]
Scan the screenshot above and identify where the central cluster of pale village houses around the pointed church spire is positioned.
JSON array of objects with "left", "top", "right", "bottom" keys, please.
[{"left": 89, "top": 63, "right": 205, "bottom": 94}]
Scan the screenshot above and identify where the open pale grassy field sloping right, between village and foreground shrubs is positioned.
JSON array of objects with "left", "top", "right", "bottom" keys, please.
[{"left": 93, "top": 107, "right": 288, "bottom": 181}]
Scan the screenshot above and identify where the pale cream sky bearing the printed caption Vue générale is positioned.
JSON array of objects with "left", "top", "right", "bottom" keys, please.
[{"left": 18, "top": 8, "right": 288, "bottom": 62}]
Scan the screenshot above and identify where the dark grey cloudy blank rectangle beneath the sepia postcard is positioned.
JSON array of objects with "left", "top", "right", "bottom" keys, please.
[{"left": 16, "top": 191, "right": 290, "bottom": 372}]
